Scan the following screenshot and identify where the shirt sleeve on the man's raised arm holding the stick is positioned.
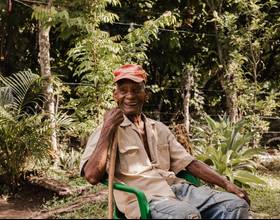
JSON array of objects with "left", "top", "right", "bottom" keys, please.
[{"left": 80, "top": 126, "right": 102, "bottom": 176}]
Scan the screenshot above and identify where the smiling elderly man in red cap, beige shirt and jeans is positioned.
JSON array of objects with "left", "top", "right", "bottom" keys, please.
[{"left": 81, "top": 64, "right": 250, "bottom": 219}]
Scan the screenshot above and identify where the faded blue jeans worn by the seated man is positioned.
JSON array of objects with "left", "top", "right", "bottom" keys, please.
[{"left": 150, "top": 183, "right": 249, "bottom": 219}]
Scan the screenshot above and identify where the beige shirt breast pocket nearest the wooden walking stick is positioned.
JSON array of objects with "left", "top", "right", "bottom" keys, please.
[{"left": 119, "top": 145, "right": 144, "bottom": 174}]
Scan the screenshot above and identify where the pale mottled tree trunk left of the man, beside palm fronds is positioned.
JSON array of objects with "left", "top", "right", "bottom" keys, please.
[{"left": 39, "top": 0, "right": 58, "bottom": 158}]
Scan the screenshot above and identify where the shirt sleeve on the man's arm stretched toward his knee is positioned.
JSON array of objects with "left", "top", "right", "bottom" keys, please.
[{"left": 168, "top": 129, "right": 195, "bottom": 174}]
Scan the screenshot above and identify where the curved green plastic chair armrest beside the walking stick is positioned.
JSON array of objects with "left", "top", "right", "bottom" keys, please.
[{"left": 101, "top": 179, "right": 151, "bottom": 219}]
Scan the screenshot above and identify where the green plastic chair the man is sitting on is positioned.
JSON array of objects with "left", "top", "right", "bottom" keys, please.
[{"left": 102, "top": 171, "right": 201, "bottom": 219}]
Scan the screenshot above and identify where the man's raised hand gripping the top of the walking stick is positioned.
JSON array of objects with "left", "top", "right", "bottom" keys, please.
[{"left": 103, "top": 107, "right": 124, "bottom": 131}]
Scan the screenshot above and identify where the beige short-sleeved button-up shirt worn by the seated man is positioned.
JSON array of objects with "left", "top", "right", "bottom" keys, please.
[{"left": 80, "top": 116, "right": 194, "bottom": 218}]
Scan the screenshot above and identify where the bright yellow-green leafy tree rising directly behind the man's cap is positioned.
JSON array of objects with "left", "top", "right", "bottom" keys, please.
[{"left": 52, "top": 1, "right": 175, "bottom": 135}]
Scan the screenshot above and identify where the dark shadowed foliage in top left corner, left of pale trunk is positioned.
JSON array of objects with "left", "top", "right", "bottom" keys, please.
[{"left": 0, "top": 1, "right": 38, "bottom": 76}]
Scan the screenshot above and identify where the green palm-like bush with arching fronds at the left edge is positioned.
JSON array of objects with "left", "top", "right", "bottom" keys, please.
[{"left": 0, "top": 71, "right": 51, "bottom": 186}]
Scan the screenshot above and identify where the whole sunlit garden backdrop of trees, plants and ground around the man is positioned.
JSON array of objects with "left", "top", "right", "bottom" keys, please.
[{"left": 0, "top": 0, "right": 280, "bottom": 218}]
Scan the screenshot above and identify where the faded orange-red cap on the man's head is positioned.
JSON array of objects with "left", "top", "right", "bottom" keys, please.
[{"left": 113, "top": 64, "right": 147, "bottom": 83}]
